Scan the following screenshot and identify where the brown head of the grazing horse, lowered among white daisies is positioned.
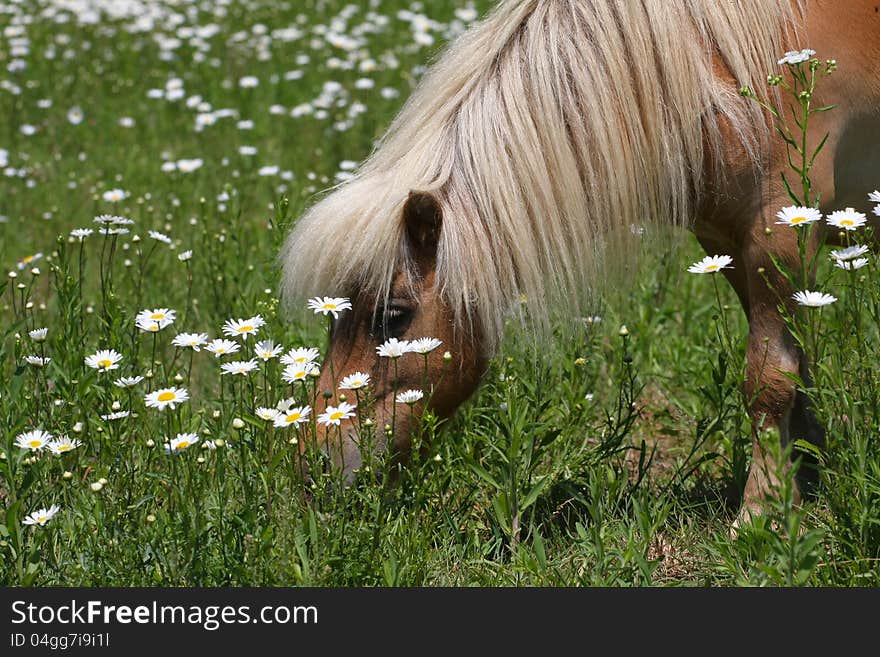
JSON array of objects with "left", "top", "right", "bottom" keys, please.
[{"left": 303, "top": 192, "right": 487, "bottom": 483}]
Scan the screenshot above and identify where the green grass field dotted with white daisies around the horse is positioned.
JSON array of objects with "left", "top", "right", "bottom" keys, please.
[{"left": 0, "top": 0, "right": 880, "bottom": 586}]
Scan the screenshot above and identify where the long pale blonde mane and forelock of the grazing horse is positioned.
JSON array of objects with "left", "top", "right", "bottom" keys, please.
[{"left": 281, "top": 0, "right": 798, "bottom": 349}]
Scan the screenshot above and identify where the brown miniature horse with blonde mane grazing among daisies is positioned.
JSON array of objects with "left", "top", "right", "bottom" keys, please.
[{"left": 280, "top": 0, "right": 880, "bottom": 519}]
